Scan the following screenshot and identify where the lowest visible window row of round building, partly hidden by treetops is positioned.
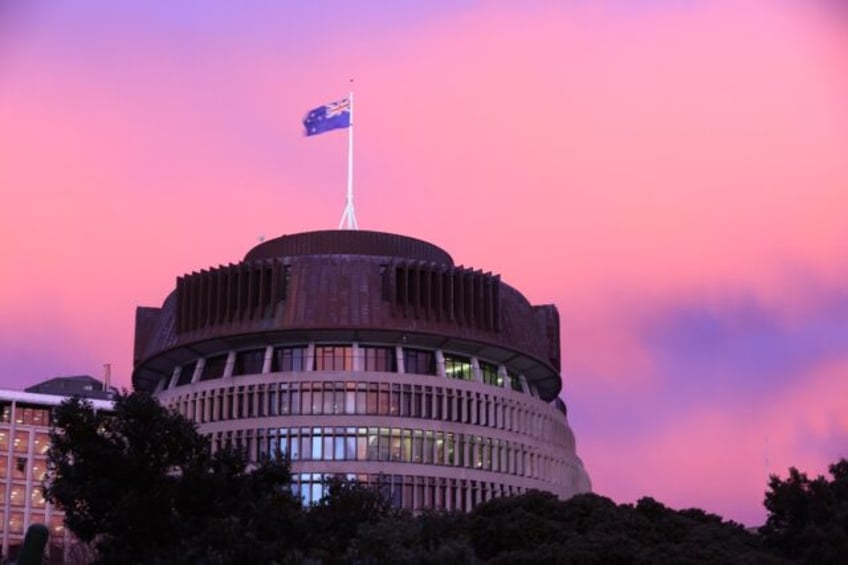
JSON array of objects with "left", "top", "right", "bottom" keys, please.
[{"left": 292, "top": 473, "right": 523, "bottom": 512}]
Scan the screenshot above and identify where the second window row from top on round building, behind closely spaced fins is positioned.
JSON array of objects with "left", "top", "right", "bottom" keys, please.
[{"left": 171, "top": 381, "right": 568, "bottom": 445}]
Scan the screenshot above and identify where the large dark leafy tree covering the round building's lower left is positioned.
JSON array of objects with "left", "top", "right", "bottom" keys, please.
[{"left": 45, "top": 393, "right": 302, "bottom": 563}]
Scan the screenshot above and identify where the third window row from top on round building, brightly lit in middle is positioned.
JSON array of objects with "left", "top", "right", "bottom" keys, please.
[{"left": 212, "top": 427, "right": 565, "bottom": 482}]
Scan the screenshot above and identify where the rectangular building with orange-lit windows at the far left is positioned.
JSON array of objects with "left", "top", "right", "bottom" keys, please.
[{"left": 0, "top": 377, "right": 112, "bottom": 563}]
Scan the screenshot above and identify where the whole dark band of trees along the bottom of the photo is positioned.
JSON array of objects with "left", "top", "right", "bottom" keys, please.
[{"left": 45, "top": 393, "right": 848, "bottom": 565}]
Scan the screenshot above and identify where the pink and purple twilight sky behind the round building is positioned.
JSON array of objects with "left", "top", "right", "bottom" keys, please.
[{"left": 0, "top": 0, "right": 848, "bottom": 525}]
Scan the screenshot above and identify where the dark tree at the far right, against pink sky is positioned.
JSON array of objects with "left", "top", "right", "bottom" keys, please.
[{"left": 760, "top": 459, "right": 848, "bottom": 564}]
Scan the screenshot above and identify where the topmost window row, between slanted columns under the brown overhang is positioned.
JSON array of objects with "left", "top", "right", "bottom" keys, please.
[{"left": 176, "top": 345, "right": 523, "bottom": 392}]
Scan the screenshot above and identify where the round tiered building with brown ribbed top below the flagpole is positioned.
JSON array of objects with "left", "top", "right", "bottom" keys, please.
[{"left": 133, "top": 230, "right": 591, "bottom": 510}]
